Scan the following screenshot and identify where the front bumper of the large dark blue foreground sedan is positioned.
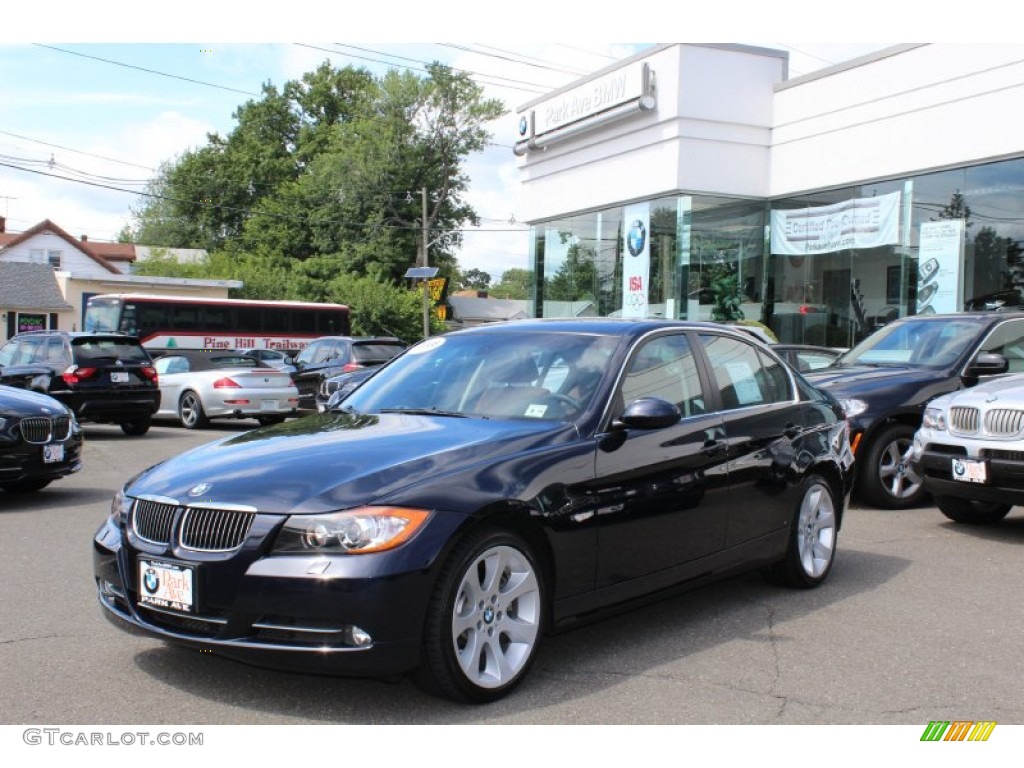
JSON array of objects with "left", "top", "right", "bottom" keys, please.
[{"left": 93, "top": 512, "right": 462, "bottom": 677}]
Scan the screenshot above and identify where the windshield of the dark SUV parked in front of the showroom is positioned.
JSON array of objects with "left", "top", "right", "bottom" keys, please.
[{"left": 839, "top": 318, "right": 982, "bottom": 368}]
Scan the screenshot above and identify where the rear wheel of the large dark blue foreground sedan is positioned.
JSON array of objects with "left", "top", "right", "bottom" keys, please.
[{"left": 764, "top": 475, "right": 839, "bottom": 589}]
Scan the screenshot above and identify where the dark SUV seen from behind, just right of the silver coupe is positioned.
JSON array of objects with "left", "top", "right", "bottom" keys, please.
[{"left": 292, "top": 336, "right": 407, "bottom": 411}]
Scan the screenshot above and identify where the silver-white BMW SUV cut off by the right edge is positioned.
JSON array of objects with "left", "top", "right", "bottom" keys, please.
[{"left": 911, "top": 376, "right": 1024, "bottom": 525}]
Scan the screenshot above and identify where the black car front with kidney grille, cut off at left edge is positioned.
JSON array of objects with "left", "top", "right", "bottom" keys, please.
[{"left": 0, "top": 386, "right": 82, "bottom": 494}]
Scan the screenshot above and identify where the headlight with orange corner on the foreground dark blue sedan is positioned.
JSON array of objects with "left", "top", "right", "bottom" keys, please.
[{"left": 273, "top": 507, "right": 430, "bottom": 555}]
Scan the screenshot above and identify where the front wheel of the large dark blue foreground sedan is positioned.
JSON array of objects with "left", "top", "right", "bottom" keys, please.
[{"left": 418, "top": 529, "right": 547, "bottom": 702}]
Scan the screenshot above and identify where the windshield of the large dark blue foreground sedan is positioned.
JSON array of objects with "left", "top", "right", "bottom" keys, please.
[{"left": 343, "top": 332, "right": 618, "bottom": 421}]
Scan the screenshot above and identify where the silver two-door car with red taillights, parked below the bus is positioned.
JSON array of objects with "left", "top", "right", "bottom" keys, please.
[{"left": 155, "top": 350, "right": 299, "bottom": 429}]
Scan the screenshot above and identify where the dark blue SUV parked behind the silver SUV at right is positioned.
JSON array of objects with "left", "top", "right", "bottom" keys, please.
[{"left": 804, "top": 312, "right": 1024, "bottom": 509}]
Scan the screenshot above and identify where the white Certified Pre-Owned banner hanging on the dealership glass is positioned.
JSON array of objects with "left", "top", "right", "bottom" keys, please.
[{"left": 771, "top": 191, "right": 900, "bottom": 256}]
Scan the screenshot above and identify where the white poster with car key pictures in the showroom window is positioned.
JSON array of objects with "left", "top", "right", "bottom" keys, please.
[{"left": 918, "top": 219, "right": 964, "bottom": 314}]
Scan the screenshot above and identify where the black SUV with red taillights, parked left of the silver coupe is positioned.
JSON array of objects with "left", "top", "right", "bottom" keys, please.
[{"left": 0, "top": 331, "right": 160, "bottom": 435}]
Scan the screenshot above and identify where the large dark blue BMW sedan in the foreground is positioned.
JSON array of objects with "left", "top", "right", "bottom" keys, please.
[{"left": 94, "top": 318, "right": 853, "bottom": 701}]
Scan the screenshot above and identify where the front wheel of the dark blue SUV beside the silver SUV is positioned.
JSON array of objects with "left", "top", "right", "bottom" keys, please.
[{"left": 859, "top": 424, "right": 927, "bottom": 509}]
